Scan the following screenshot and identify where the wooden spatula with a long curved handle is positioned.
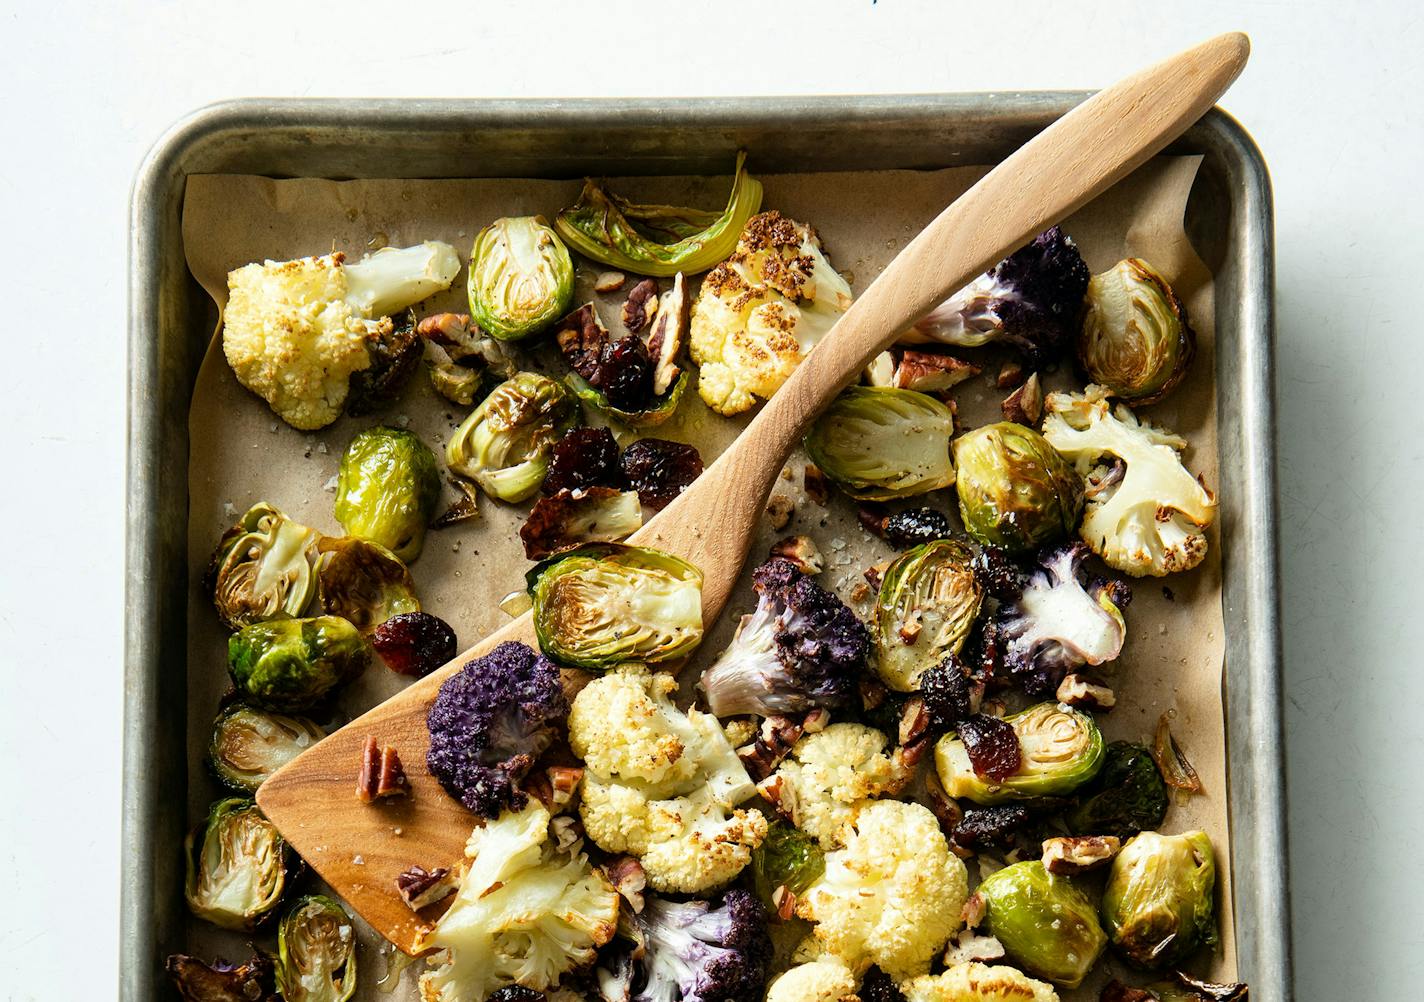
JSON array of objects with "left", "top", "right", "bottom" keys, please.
[{"left": 258, "top": 34, "right": 1250, "bottom": 952}]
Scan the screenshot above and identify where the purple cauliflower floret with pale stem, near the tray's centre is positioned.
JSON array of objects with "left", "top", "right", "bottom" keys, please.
[{"left": 698, "top": 558, "right": 870, "bottom": 717}]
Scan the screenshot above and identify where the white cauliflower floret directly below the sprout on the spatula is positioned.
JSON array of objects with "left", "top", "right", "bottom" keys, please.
[{"left": 568, "top": 669, "right": 766, "bottom": 892}]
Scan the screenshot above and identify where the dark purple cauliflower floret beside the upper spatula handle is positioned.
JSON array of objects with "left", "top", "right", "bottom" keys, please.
[{"left": 900, "top": 226, "right": 1088, "bottom": 369}]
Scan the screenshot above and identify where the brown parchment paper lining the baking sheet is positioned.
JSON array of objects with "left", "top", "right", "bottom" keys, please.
[{"left": 183, "top": 158, "right": 1249, "bottom": 999}]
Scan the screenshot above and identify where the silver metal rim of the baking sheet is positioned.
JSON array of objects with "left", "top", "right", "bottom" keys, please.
[{"left": 120, "top": 91, "right": 1294, "bottom": 1002}]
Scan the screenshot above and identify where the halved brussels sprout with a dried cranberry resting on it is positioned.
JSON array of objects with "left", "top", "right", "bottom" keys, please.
[{"left": 934, "top": 703, "right": 1102, "bottom": 804}]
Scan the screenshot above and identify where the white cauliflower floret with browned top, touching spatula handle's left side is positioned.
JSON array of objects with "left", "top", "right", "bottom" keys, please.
[{"left": 688, "top": 212, "right": 852, "bottom": 414}]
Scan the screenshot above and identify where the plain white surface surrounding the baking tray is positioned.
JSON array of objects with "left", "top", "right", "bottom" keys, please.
[{"left": 0, "top": 0, "right": 1424, "bottom": 1002}]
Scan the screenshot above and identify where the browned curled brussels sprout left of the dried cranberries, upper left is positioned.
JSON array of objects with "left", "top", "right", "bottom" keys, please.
[{"left": 446, "top": 373, "right": 578, "bottom": 501}]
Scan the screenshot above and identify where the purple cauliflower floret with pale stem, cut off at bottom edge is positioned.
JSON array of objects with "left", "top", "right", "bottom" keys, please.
[{"left": 597, "top": 890, "right": 772, "bottom": 1002}]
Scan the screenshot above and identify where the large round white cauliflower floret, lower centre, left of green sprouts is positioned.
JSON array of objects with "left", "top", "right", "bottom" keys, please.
[{"left": 796, "top": 800, "right": 968, "bottom": 981}]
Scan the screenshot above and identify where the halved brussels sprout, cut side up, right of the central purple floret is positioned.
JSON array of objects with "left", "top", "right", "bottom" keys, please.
[{"left": 876, "top": 539, "right": 984, "bottom": 692}]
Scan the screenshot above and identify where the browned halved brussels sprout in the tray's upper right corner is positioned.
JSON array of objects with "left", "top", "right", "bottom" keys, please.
[{"left": 1078, "top": 258, "right": 1196, "bottom": 404}]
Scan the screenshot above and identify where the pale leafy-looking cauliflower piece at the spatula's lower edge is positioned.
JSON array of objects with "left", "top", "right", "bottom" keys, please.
[{"left": 419, "top": 800, "right": 618, "bottom": 1002}]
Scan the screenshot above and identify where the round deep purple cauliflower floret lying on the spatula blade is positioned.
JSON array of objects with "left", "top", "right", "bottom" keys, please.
[{"left": 426, "top": 643, "right": 568, "bottom": 820}]
